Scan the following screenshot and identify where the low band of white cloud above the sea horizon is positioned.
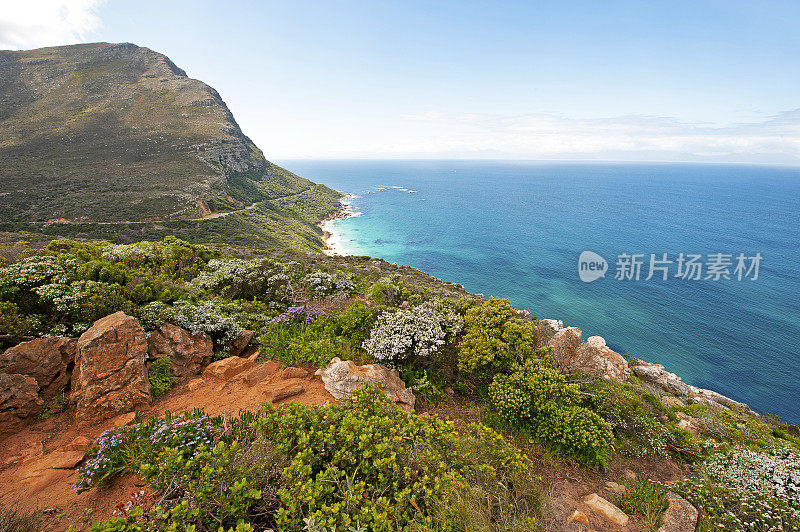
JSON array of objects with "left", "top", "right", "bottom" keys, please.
[{"left": 328, "top": 109, "right": 800, "bottom": 164}]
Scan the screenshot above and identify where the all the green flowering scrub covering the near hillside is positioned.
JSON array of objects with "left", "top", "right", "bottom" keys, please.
[{"left": 0, "top": 238, "right": 800, "bottom": 531}]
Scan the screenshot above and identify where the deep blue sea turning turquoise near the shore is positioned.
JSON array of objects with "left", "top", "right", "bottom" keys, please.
[{"left": 282, "top": 161, "right": 800, "bottom": 423}]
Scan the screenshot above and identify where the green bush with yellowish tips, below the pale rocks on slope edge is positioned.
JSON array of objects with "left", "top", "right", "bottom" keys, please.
[{"left": 489, "top": 358, "right": 614, "bottom": 466}]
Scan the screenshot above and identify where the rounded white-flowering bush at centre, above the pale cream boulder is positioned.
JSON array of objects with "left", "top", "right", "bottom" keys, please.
[{"left": 363, "top": 300, "right": 462, "bottom": 364}]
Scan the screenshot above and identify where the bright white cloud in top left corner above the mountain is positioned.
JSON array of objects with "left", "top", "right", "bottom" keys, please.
[{"left": 0, "top": 0, "right": 104, "bottom": 50}]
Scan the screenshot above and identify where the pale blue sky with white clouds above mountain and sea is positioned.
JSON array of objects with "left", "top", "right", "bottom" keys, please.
[{"left": 0, "top": 0, "right": 800, "bottom": 165}]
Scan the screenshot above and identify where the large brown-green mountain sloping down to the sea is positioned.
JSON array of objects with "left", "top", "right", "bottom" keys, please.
[{"left": 0, "top": 43, "right": 340, "bottom": 248}]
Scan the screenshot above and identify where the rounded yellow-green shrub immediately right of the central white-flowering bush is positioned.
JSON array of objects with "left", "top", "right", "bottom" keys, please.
[{"left": 458, "top": 298, "right": 534, "bottom": 376}]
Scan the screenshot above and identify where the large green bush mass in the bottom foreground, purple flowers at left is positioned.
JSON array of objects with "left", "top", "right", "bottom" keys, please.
[{"left": 81, "top": 388, "right": 541, "bottom": 532}]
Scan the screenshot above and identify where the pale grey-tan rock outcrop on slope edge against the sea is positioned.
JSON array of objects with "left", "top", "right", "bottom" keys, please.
[{"left": 549, "top": 327, "right": 631, "bottom": 382}]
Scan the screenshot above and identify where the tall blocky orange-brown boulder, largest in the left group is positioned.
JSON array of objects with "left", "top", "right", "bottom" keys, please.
[{"left": 71, "top": 312, "right": 150, "bottom": 424}]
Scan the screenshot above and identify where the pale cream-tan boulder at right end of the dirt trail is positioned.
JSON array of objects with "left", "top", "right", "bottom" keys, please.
[{"left": 316, "top": 357, "right": 416, "bottom": 412}]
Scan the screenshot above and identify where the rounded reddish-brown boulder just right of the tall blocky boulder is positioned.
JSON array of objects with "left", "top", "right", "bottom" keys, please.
[{"left": 147, "top": 323, "right": 214, "bottom": 377}]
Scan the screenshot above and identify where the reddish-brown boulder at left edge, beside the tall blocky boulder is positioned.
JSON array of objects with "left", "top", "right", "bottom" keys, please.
[{"left": 0, "top": 336, "right": 78, "bottom": 399}]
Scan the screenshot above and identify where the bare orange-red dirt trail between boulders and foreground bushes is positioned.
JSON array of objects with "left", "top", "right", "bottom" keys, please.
[{"left": 0, "top": 361, "right": 335, "bottom": 530}]
